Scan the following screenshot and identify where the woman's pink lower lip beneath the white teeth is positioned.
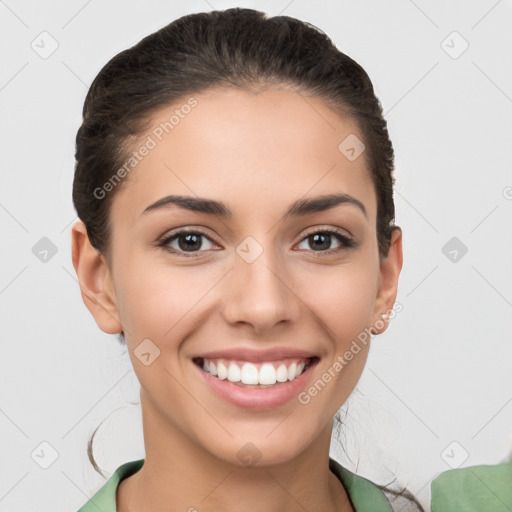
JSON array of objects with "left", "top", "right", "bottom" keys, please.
[{"left": 192, "top": 361, "right": 318, "bottom": 409}]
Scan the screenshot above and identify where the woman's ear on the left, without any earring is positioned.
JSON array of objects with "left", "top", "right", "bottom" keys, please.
[{"left": 71, "top": 221, "right": 123, "bottom": 334}]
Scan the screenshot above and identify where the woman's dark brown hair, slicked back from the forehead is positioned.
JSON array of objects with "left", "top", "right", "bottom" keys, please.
[{"left": 73, "top": 8, "right": 422, "bottom": 510}]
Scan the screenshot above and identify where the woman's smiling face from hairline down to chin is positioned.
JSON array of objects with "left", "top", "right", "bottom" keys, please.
[{"left": 72, "top": 88, "right": 401, "bottom": 464}]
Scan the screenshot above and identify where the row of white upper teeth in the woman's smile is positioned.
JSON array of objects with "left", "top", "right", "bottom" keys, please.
[{"left": 203, "top": 359, "right": 312, "bottom": 386}]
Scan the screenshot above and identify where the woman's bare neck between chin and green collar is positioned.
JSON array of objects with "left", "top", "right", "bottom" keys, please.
[{"left": 116, "top": 393, "right": 353, "bottom": 512}]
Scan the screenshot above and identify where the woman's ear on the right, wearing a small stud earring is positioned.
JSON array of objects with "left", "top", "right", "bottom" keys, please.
[{"left": 371, "top": 226, "right": 403, "bottom": 334}]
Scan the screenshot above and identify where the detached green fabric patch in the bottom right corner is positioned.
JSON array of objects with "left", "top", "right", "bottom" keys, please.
[{"left": 431, "top": 461, "right": 512, "bottom": 512}]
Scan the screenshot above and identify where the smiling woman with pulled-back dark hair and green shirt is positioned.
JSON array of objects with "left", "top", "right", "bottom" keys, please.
[{"left": 72, "top": 9, "right": 421, "bottom": 512}]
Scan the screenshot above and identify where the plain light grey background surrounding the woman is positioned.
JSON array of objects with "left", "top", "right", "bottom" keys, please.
[{"left": 0, "top": 0, "right": 512, "bottom": 512}]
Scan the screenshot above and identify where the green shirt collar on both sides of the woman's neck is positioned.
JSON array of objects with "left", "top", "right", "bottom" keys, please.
[{"left": 78, "top": 459, "right": 392, "bottom": 512}]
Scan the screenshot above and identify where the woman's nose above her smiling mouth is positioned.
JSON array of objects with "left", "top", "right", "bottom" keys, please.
[{"left": 223, "top": 244, "right": 301, "bottom": 335}]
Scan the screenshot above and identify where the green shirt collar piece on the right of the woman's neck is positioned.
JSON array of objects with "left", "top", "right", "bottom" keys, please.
[{"left": 329, "top": 458, "right": 392, "bottom": 512}]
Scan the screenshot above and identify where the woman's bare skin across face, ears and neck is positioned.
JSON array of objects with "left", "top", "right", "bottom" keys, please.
[{"left": 72, "top": 86, "right": 402, "bottom": 512}]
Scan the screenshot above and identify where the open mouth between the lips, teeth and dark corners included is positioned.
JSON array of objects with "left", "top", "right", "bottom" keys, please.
[{"left": 192, "top": 356, "right": 320, "bottom": 388}]
